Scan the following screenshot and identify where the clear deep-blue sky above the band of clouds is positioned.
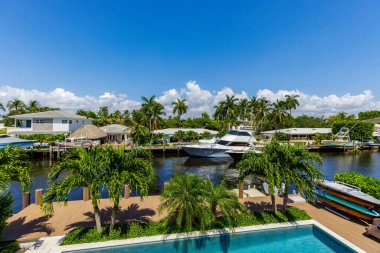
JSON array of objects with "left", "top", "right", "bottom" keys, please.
[{"left": 0, "top": 0, "right": 380, "bottom": 115}]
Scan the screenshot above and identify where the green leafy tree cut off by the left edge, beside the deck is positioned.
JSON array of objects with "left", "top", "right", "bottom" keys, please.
[{"left": 0, "top": 147, "right": 32, "bottom": 237}]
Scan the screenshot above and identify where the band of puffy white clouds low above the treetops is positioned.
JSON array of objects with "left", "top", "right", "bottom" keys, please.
[{"left": 0, "top": 81, "right": 380, "bottom": 117}]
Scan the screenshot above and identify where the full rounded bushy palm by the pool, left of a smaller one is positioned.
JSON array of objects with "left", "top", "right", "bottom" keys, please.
[{"left": 159, "top": 174, "right": 214, "bottom": 232}]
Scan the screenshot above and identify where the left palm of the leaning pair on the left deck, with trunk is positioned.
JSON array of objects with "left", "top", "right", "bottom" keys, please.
[{"left": 42, "top": 146, "right": 109, "bottom": 233}]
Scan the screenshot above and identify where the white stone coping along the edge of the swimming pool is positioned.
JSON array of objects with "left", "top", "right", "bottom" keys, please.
[{"left": 27, "top": 220, "right": 366, "bottom": 253}]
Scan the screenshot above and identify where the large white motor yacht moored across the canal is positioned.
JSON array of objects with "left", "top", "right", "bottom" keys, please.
[{"left": 182, "top": 130, "right": 256, "bottom": 158}]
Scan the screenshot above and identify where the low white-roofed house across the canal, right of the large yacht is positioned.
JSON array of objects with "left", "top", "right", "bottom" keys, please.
[{"left": 262, "top": 128, "right": 332, "bottom": 140}]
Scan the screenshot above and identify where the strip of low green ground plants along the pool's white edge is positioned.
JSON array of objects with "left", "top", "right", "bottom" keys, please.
[{"left": 61, "top": 207, "right": 311, "bottom": 245}]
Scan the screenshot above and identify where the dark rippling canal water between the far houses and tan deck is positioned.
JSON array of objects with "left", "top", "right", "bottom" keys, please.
[{"left": 11, "top": 151, "right": 380, "bottom": 213}]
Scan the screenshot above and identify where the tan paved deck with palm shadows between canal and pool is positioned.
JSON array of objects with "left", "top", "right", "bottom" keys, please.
[{"left": 3, "top": 196, "right": 380, "bottom": 252}]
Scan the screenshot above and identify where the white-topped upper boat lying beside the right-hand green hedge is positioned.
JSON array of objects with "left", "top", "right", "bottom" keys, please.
[{"left": 318, "top": 180, "right": 380, "bottom": 208}]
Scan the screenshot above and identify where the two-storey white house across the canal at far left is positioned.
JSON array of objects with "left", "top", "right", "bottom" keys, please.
[{"left": 7, "top": 111, "right": 92, "bottom": 135}]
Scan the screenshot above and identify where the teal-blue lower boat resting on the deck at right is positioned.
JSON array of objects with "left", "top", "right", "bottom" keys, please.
[{"left": 315, "top": 189, "right": 380, "bottom": 221}]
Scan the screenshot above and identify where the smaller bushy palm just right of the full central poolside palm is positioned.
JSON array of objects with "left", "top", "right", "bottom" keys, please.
[{"left": 207, "top": 179, "right": 246, "bottom": 227}]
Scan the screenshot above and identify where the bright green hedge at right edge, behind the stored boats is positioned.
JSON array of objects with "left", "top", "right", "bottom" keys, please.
[{"left": 334, "top": 172, "right": 380, "bottom": 199}]
